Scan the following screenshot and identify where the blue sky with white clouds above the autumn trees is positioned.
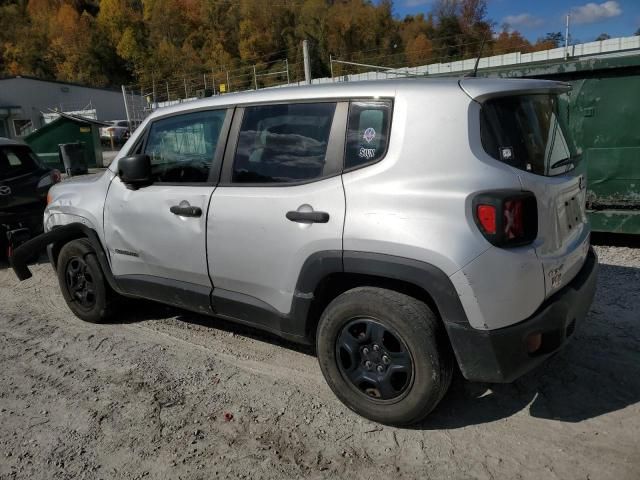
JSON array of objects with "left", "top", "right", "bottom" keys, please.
[{"left": 394, "top": 0, "right": 640, "bottom": 42}]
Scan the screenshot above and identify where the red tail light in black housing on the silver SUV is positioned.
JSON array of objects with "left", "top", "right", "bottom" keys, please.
[{"left": 473, "top": 190, "right": 538, "bottom": 247}]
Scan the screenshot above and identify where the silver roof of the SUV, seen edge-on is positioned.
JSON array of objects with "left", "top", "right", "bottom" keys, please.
[{"left": 149, "top": 77, "right": 565, "bottom": 119}]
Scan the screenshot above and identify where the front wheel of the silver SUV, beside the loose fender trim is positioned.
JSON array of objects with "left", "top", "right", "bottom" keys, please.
[{"left": 56, "top": 238, "right": 119, "bottom": 323}]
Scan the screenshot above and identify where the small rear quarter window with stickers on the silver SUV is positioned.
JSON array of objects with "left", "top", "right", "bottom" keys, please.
[{"left": 344, "top": 100, "right": 391, "bottom": 169}]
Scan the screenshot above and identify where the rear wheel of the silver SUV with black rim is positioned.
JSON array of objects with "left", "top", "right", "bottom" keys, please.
[{"left": 316, "top": 287, "right": 454, "bottom": 426}]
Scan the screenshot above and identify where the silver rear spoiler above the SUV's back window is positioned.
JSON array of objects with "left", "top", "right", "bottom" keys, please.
[{"left": 458, "top": 77, "right": 571, "bottom": 103}]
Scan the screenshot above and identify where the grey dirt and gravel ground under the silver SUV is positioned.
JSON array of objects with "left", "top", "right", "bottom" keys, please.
[{"left": 0, "top": 247, "right": 640, "bottom": 480}]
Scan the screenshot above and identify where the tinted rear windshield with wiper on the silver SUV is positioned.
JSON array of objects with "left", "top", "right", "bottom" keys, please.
[{"left": 480, "top": 95, "right": 579, "bottom": 176}]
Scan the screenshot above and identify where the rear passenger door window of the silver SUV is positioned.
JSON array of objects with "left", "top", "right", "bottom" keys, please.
[{"left": 232, "top": 103, "right": 336, "bottom": 183}]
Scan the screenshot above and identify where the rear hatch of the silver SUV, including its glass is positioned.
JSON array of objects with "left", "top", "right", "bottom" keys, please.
[{"left": 461, "top": 80, "right": 590, "bottom": 297}]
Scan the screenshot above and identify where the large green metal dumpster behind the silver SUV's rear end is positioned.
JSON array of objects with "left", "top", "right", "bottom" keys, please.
[{"left": 478, "top": 52, "right": 640, "bottom": 234}]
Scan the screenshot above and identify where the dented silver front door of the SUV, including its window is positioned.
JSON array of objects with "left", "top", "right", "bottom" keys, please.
[{"left": 104, "top": 109, "right": 232, "bottom": 304}]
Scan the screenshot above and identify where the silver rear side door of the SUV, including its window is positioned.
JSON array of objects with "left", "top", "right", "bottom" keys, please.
[{"left": 207, "top": 101, "right": 348, "bottom": 318}]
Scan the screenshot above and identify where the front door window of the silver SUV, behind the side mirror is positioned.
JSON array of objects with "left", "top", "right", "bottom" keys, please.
[{"left": 144, "top": 110, "right": 226, "bottom": 183}]
